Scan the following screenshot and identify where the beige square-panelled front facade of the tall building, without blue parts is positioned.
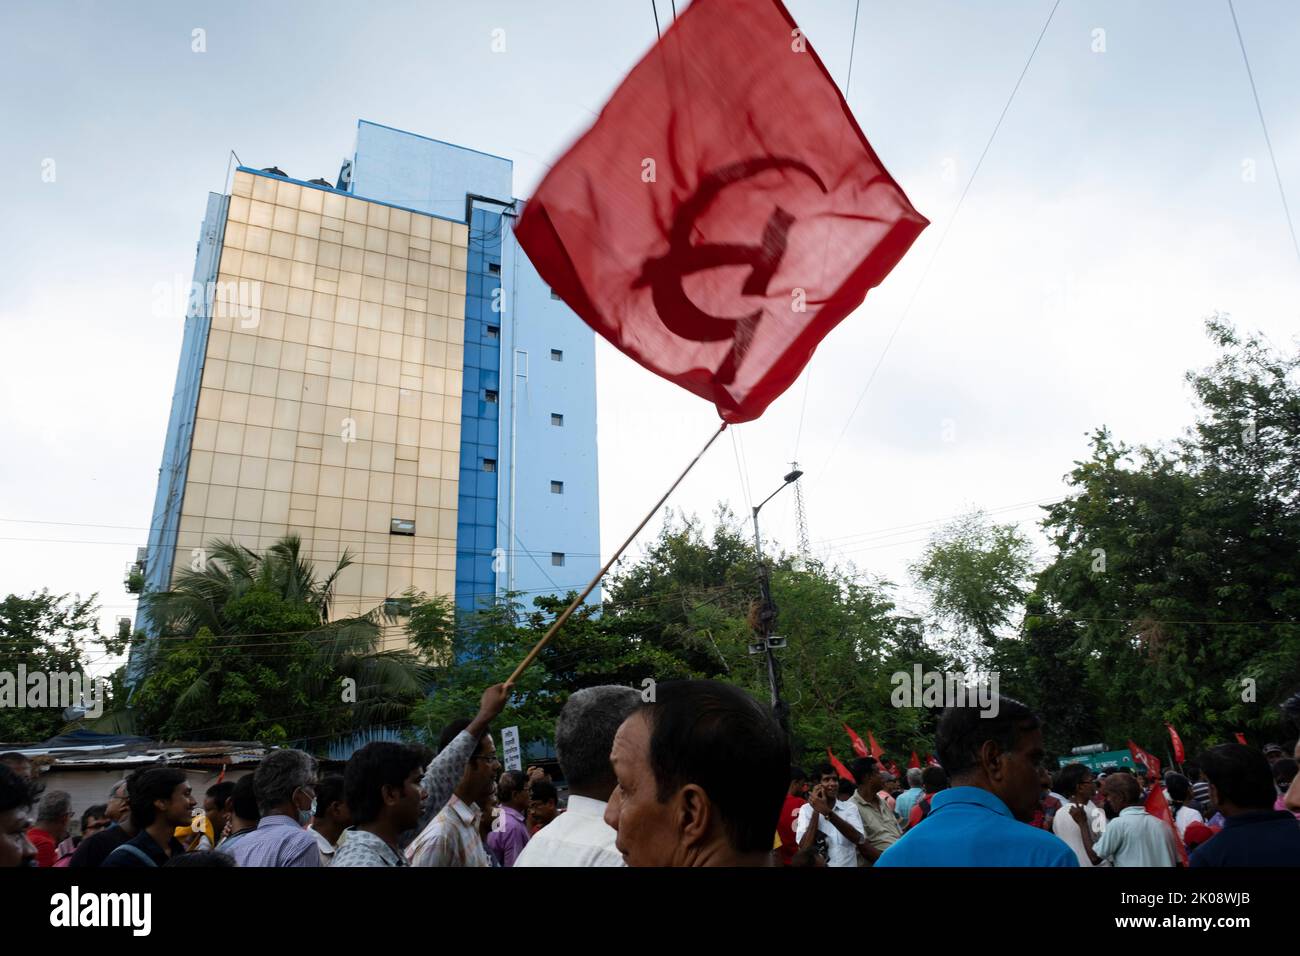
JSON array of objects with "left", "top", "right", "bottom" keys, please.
[{"left": 173, "top": 172, "right": 467, "bottom": 617}]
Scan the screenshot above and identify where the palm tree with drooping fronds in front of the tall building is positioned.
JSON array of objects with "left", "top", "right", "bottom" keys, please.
[{"left": 120, "top": 535, "right": 432, "bottom": 739}]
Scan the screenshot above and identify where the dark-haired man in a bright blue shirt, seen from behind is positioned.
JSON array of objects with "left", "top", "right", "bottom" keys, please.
[{"left": 876, "top": 697, "right": 1079, "bottom": 866}]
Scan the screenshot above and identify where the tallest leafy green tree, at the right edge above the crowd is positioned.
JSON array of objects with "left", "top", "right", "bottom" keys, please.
[{"left": 1037, "top": 316, "right": 1300, "bottom": 750}]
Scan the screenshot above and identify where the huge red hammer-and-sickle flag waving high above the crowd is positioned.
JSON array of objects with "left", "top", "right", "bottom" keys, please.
[{"left": 515, "top": 0, "right": 928, "bottom": 423}]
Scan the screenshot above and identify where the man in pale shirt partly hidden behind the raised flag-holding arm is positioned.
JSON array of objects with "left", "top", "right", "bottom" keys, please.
[{"left": 406, "top": 719, "right": 501, "bottom": 866}]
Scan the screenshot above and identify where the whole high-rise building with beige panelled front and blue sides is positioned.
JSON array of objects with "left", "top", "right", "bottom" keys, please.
[{"left": 131, "top": 121, "right": 599, "bottom": 676}]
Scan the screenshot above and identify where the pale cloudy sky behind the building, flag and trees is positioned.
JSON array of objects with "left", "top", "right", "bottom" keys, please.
[{"left": 0, "top": 0, "right": 1300, "bottom": 671}]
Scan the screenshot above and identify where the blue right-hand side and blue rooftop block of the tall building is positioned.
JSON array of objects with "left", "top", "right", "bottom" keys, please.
[{"left": 350, "top": 120, "right": 601, "bottom": 610}]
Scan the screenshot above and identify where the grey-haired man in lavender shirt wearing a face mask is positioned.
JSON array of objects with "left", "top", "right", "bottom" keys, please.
[{"left": 230, "top": 750, "right": 321, "bottom": 866}]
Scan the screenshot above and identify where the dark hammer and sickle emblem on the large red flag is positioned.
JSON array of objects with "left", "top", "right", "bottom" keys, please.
[{"left": 632, "top": 156, "right": 827, "bottom": 369}]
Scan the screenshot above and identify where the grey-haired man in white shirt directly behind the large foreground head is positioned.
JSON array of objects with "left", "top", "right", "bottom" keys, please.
[{"left": 515, "top": 684, "right": 641, "bottom": 866}]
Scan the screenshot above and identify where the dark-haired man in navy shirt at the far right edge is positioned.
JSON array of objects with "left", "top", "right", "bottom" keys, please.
[{"left": 1191, "top": 744, "right": 1300, "bottom": 866}]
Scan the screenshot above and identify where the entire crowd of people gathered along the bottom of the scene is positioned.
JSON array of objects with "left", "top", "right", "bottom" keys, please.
[{"left": 0, "top": 680, "right": 1300, "bottom": 868}]
